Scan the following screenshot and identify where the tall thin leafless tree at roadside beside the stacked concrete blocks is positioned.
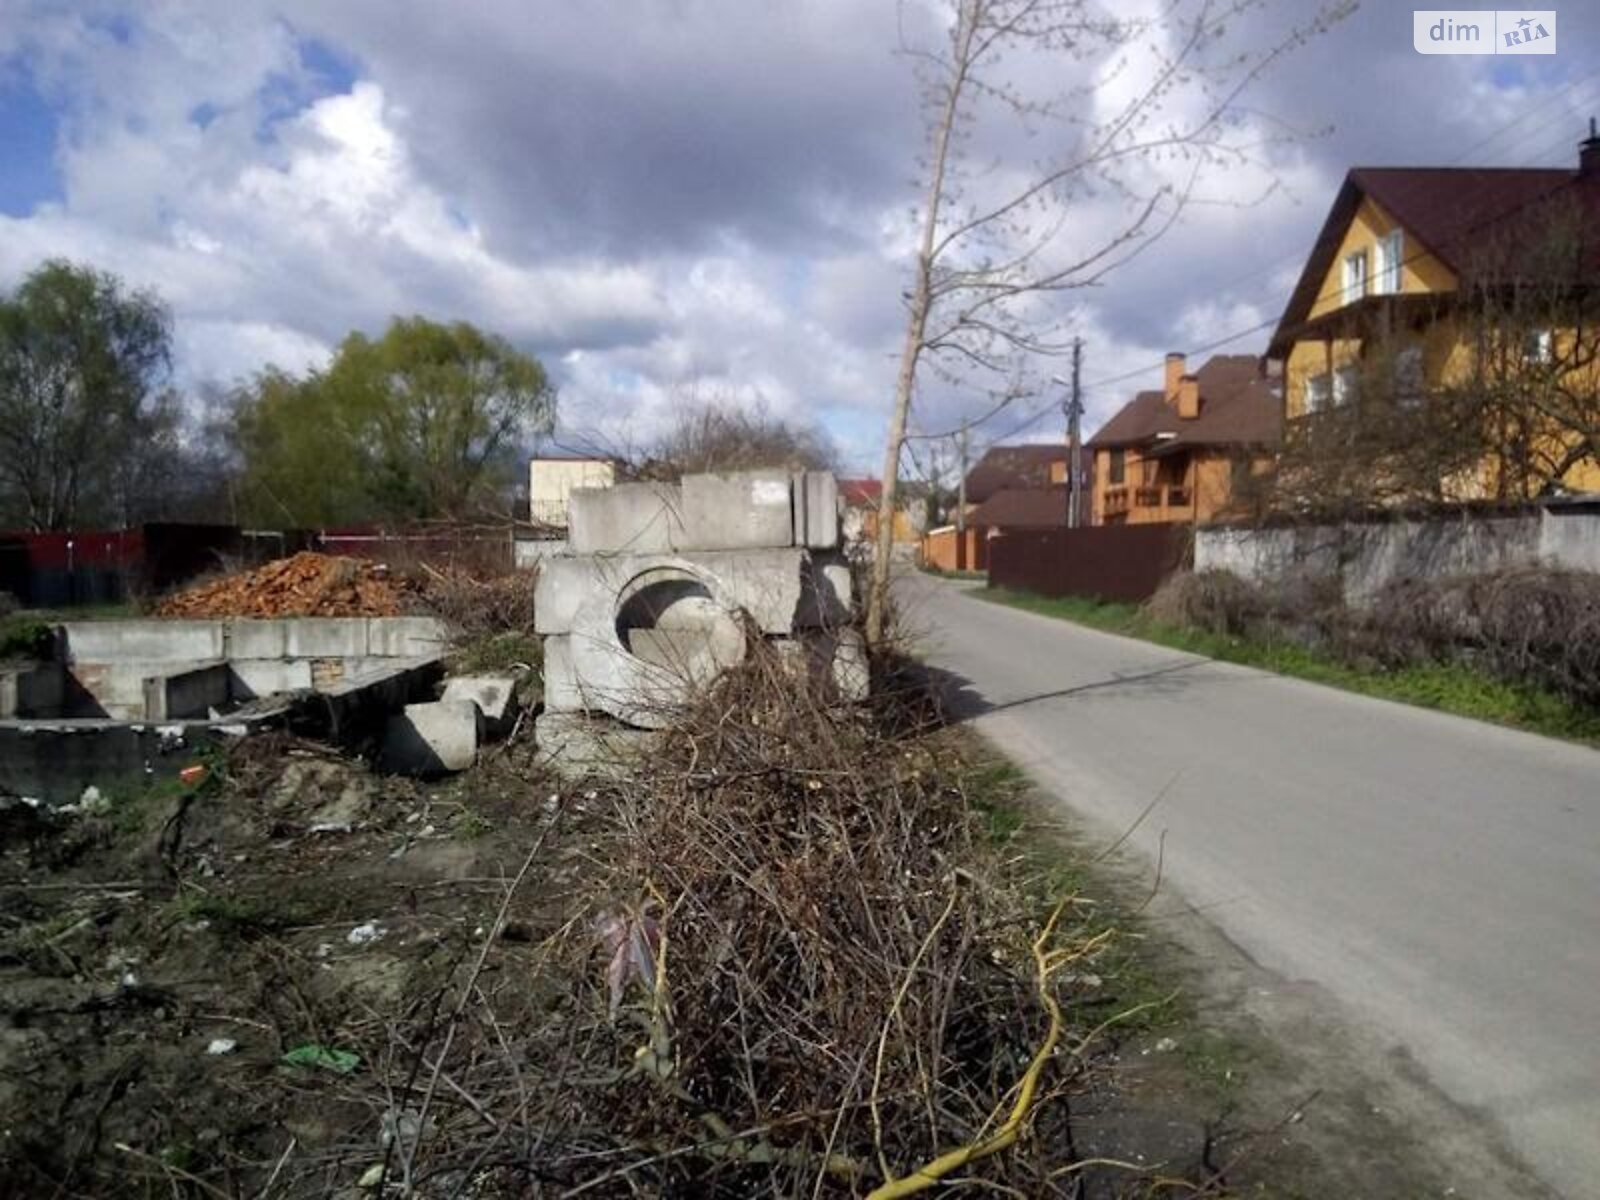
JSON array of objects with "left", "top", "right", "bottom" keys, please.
[{"left": 867, "top": 0, "right": 1355, "bottom": 642}]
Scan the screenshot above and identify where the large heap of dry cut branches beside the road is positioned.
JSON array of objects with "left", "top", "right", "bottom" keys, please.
[{"left": 361, "top": 651, "right": 1132, "bottom": 1197}]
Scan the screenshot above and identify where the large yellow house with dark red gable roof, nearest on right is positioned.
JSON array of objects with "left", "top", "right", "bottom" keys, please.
[{"left": 1267, "top": 133, "right": 1600, "bottom": 501}]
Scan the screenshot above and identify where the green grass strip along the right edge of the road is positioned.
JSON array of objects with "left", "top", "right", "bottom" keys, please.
[{"left": 979, "top": 587, "right": 1600, "bottom": 744}]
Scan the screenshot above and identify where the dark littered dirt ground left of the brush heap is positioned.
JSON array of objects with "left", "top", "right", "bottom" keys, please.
[{"left": 0, "top": 739, "right": 565, "bottom": 1197}]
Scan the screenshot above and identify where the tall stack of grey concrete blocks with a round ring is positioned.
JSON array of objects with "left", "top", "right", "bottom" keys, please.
[{"left": 534, "top": 470, "right": 869, "bottom": 773}]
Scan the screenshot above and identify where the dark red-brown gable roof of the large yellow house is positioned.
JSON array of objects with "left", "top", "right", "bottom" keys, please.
[{"left": 1267, "top": 166, "right": 1600, "bottom": 358}]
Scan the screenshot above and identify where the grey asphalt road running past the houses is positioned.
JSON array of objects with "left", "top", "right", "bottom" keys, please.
[{"left": 899, "top": 576, "right": 1600, "bottom": 1198}]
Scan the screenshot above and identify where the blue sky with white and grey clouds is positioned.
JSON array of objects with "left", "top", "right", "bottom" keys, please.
[{"left": 0, "top": 0, "right": 1600, "bottom": 470}]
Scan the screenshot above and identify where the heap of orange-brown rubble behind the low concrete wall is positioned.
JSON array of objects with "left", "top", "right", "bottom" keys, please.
[{"left": 155, "top": 550, "right": 411, "bottom": 618}]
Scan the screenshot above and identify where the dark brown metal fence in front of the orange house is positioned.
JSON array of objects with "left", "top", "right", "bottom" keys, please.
[{"left": 989, "top": 523, "right": 1194, "bottom": 603}]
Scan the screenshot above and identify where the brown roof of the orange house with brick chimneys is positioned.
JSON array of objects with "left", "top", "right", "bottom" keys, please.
[{"left": 1088, "top": 354, "right": 1283, "bottom": 450}]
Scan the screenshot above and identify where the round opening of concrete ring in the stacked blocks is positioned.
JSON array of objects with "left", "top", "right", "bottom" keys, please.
[{"left": 616, "top": 566, "right": 746, "bottom": 685}]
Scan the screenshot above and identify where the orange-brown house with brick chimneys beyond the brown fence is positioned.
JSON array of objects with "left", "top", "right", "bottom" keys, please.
[{"left": 1088, "top": 354, "right": 1283, "bottom": 525}]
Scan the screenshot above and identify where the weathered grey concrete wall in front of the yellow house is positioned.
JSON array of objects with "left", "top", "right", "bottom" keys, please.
[{"left": 1194, "top": 502, "right": 1600, "bottom": 603}]
